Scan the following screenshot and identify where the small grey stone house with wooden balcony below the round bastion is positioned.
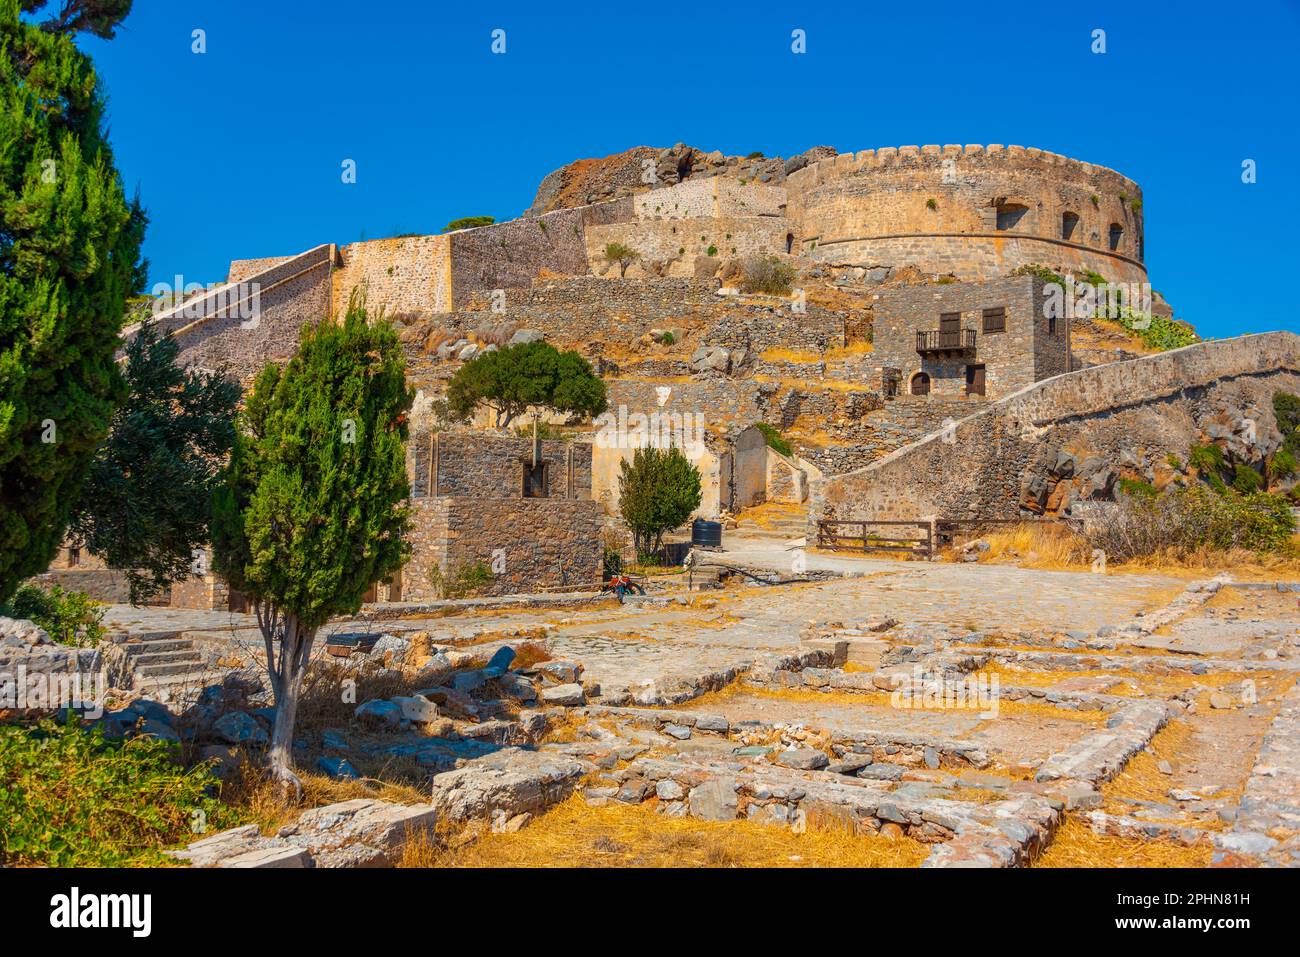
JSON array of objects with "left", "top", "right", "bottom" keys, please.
[{"left": 872, "top": 276, "right": 1070, "bottom": 399}]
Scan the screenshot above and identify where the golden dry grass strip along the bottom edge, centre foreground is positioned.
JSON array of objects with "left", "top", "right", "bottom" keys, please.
[{"left": 402, "top": 796, "right": 928, "bottom": 867}]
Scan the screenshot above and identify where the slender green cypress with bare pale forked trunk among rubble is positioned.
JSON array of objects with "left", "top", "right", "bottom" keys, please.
[{"left": 212, "top": 299, "right": 415, "bottom": 789}]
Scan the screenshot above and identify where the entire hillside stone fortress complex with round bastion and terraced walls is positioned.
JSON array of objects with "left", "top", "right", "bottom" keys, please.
[{"left": 76, "top": 144, "right": 1300, "bottom": 608}]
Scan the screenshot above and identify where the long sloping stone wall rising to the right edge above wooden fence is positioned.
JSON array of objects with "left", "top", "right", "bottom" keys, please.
[{"left": 809, "top": 333, "right": 1300, "bottom": 534}]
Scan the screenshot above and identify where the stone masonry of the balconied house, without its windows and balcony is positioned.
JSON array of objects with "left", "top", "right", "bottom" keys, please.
[{"left": 872, "top": 276, "right": 1070, "bottom": 399}]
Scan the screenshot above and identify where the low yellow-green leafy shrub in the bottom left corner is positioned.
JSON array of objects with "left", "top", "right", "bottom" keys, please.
[{"left": 0, "top": 718, "right": 233, "bottom": 867}]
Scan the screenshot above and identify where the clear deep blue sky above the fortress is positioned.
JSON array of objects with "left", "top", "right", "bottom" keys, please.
[{"left": 82, "top": 0, "right": 1300, "bottom": 335}]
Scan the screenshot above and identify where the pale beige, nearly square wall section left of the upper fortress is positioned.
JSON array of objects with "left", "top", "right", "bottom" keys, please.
[{"left": 334, "top": 235, "right": 451, "bottom": 316}]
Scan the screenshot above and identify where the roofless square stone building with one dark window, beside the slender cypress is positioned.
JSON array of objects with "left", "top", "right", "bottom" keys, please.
[{"left": 400, "top": 433, "right": 603, "bottom": 601}]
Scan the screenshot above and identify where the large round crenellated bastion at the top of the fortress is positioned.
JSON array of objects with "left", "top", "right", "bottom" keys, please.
[{"left": 785, "top": 144, "right": 1143, "bottom": 280}]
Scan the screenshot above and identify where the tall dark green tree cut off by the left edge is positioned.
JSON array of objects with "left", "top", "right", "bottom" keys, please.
[{"left": 0, "top": 0, "right": 144, "bottom": 601}]
